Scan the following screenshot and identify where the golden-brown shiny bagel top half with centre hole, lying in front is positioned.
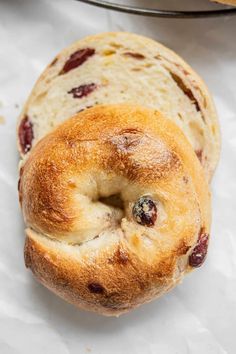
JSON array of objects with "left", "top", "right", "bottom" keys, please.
[{"left": 19, "top": 105, "right": 211, "bottom": 316}]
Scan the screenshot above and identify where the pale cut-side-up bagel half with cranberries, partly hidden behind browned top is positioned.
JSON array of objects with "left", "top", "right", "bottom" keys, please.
[{"left": 18, "top": 32, "right": 220, "bottom": 181}]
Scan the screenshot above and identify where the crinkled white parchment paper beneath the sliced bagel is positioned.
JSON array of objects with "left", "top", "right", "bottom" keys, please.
[{"left": 0, "top": 0, "right": 236, "bottom": 354}]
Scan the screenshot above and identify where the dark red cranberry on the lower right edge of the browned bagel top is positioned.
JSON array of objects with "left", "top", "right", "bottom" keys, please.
[{"left": 189, "top": 230, "right": 209, "bottom": 268}]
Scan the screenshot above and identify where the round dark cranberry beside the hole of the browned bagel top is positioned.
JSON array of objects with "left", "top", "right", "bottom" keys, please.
[{"left": 133, "top": 196, "right": 157, "bottom": 227}]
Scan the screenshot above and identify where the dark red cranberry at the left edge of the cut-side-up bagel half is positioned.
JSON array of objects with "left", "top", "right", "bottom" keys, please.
[{"left": 18, "top": 116, "right": 34, "bottom": 154}]
